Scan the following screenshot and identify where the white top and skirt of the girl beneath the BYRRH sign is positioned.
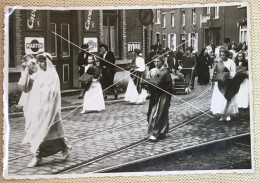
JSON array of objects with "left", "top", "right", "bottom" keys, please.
[{"left": 125, "top": 57, "right": 148, "bottom": 103}]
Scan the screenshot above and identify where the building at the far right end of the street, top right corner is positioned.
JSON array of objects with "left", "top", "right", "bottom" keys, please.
[{"left": 202, "top": 5, "right": 248, "bottom": 46}]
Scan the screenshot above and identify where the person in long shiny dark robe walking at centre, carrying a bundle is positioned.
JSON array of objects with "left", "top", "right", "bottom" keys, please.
[{"left": 142, "top": 55, "right": 172, "bottom": 141}]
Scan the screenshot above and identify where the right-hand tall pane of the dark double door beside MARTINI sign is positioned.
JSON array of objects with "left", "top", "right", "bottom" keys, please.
[{"left": 61, "top": 24, "right": 70, "bottom": 57}]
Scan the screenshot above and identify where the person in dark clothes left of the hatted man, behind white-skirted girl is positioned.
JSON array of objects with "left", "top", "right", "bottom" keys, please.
[{"left": 78, "top": 44, "right": 90, "bottom": 99}]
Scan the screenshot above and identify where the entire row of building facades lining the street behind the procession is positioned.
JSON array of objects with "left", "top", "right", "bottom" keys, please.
[{"left": 9, "top": 6, "right": 248, "bottom": 92}]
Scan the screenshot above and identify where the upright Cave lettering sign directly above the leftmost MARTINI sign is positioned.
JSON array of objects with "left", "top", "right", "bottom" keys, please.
[{"left": 26, "top": 10, "right": 43, "bottom": 31}]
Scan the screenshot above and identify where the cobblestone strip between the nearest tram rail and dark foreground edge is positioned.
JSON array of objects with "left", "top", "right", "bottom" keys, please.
[{"left": 65, "top": 110, "right": 250, "bottom": 174}]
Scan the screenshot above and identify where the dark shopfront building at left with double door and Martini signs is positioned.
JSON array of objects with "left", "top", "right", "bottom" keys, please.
[{"left": 9, "top": 9, "right": 144, "bottom": 92}]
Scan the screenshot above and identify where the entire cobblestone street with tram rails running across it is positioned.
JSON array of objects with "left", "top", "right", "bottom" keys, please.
[{"left": 8, "top": 81, "right": 250, "bottom": 176}]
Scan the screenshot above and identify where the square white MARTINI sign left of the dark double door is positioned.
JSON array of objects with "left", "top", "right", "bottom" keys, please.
[{"left": 25, "top": 37, "right": 44, "bottom": 54}]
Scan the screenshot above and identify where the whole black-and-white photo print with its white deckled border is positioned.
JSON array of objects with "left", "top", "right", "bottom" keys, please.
[{"left": 3, "top": 2, "right": 254, "bottom": 179}]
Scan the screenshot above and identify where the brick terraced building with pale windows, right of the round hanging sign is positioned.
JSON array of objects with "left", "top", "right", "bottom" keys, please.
[{"left": 147, "top": 8, "right": 204, "bottom": 52}]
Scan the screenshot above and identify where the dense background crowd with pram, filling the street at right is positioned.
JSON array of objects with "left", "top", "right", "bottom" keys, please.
[{"left": 146, "top": 42, "right": 248, "bottom": 89}]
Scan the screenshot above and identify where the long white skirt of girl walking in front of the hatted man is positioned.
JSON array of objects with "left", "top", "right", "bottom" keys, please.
[{"left": 81, "top": 78, "right": 105, "bottom": 113}]
